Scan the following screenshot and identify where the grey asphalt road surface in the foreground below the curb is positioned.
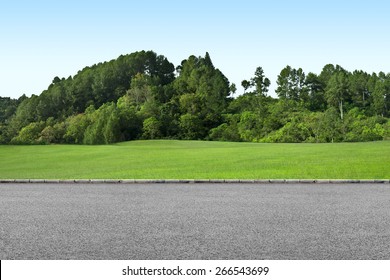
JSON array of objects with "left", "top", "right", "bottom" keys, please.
[{"left": 0, "top": 184, "right": 390, "bottom": 260}]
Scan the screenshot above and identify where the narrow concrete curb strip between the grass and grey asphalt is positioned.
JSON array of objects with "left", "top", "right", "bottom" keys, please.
[{"left": 0, "top": 179, "right": 390, "bottom": 184}]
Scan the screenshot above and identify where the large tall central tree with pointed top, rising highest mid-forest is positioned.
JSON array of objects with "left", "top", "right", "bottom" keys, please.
[{"left": 173, "top": 53, "right": 234, "bottom": 139}]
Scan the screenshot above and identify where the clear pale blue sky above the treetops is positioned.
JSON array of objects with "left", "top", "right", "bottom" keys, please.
[{"left": 0, "top": 0, "right": 390, "bottom": 98}]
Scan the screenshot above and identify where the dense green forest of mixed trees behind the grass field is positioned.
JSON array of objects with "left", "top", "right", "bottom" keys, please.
[{"left": 0, "top": 51, "right": 390, "bottom": 144}]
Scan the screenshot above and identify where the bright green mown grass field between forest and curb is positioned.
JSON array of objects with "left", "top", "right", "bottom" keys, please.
[{"left": 0, "top": 140, "right": 390, "bottom": 179}]
